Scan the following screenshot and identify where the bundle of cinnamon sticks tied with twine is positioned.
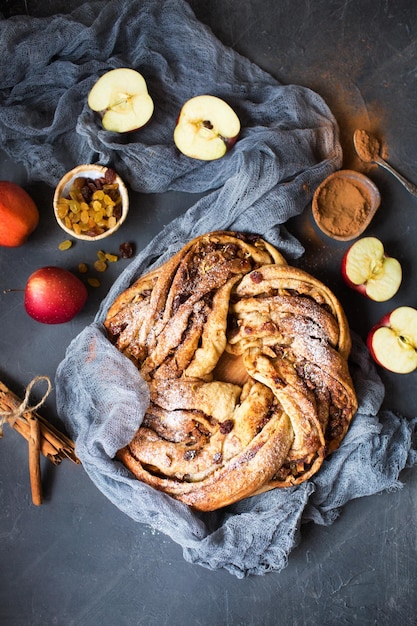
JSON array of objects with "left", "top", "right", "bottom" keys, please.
[{"left": 0, "top": 381, "right": 80, "bottom": 505}]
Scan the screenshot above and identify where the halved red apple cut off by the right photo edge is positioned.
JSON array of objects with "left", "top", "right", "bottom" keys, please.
[{"left": 367, "top": 306, "right": 417, "bottom": 374}]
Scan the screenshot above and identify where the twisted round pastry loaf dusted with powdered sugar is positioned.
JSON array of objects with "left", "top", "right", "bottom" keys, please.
[{"left": 105, "top": 231, "right": 357, "bottom": 511}]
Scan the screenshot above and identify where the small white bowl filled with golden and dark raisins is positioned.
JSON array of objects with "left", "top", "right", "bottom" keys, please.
[{"left": 53, "top": 165, "right": 129, "bottom": 241}]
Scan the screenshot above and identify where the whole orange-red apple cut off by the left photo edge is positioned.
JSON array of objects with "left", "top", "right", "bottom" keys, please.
[{"left": 0, "top": 180, "right": 39, "bottom": 248}]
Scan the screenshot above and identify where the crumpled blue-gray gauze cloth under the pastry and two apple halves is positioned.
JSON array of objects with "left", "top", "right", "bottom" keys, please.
[{"left": 0, "top": 0, "right": 417, "bottom": 577}]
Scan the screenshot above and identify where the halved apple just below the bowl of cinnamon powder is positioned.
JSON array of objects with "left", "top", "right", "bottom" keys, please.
[{"left": 342, "top": 237, "right": 402, "bottom": 302}]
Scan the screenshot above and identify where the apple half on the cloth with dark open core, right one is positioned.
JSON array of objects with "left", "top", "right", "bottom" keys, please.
[{"left": 174, "top": 95, "right": 240, "bottom": 161}]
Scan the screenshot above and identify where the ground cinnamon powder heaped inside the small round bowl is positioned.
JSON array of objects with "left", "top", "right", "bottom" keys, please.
[{"left": 317, "top": 178, "right": 371, "bottom": 237}]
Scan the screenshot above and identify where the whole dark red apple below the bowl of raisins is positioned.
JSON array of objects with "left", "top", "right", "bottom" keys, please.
[{"left": 24, "top": 266, "right": 87, "bottom": 324}]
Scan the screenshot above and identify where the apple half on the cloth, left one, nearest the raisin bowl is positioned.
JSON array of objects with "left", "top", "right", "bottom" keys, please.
[{"left": 88, "top": 67, "right": 154, "bottom": 133}]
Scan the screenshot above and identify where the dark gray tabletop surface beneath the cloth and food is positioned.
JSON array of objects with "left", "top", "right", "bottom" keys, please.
[{"left": 0, "top": 0, "right": 417, "bottom": 626}]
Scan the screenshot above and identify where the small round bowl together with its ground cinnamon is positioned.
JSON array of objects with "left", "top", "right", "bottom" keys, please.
[{"left": 312, "top": 170, "right": 381, "bottom": 241}]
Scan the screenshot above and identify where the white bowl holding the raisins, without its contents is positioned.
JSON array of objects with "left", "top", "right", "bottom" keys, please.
[{"left": 53, "top": 165, "right": 129, "bottom": 241}]
